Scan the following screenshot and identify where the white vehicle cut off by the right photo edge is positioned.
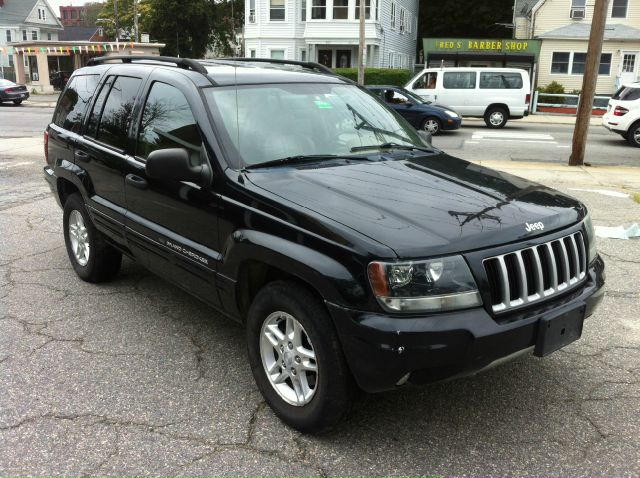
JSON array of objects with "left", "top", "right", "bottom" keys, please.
[{"left": 602, "top": 82, "right": 640, "bottom": 148}]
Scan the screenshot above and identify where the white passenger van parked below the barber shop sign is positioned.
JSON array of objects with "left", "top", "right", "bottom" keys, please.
[{"left": 405, "top": 68, "right": 531, "bottom": 128}]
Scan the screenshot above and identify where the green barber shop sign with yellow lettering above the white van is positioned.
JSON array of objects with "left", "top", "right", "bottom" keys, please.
[{"left": 422, "top": 38, "right": 541, "bottom": 78}]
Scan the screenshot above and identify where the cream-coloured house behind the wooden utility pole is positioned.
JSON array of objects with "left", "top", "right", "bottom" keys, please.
[{"left": 514, "top": 0, "right": 640, "bottom": 95}]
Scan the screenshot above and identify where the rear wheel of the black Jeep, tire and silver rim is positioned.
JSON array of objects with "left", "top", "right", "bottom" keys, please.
[{"left": 63, "top": 193, "right": 122, "bottom": 282}]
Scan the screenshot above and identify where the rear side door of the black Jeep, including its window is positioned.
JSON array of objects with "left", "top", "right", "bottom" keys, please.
[{"left": 75, "top": 71, "right": 143, "bottom": 244}]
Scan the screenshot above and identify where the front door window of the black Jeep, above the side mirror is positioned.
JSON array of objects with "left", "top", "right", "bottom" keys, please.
[{"left": 137, "top": 82, "right": 202, "bottom": 164}]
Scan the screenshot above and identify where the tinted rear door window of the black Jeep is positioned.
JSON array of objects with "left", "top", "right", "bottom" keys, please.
[{"left": 96, "top": 76, "right": 142, "bottom": 149}]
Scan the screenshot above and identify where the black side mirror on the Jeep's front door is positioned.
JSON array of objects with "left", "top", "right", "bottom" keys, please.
[{"left": 145, "top": 148, "right": 211, "bottom": 186}]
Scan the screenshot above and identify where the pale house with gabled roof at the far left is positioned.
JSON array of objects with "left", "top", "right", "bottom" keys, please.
[{"left": 0, "top": 0, "right": 63, "bottom": 80}]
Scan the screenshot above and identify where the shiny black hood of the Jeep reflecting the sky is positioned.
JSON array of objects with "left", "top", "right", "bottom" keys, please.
[{"left": 247, "top": 153, "right": 586, "bottom": 258}]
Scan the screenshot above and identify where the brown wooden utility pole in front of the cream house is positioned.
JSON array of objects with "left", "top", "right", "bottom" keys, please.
[{"left": 569, "top": 0, "right": 609, "bottom": 166}]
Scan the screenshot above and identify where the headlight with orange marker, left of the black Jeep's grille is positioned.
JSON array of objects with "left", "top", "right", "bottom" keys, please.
[{"left": 368, "top": 256, "right": 482, "bottom": 312}]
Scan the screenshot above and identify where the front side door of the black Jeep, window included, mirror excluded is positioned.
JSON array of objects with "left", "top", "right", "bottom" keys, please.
[{"left": 125, "top": 69, "right": 220, "bottom": 305}]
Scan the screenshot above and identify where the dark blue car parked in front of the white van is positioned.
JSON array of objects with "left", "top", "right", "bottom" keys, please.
[{"left": 367, "top": 85, "right": 462, "bottom": 136}]
